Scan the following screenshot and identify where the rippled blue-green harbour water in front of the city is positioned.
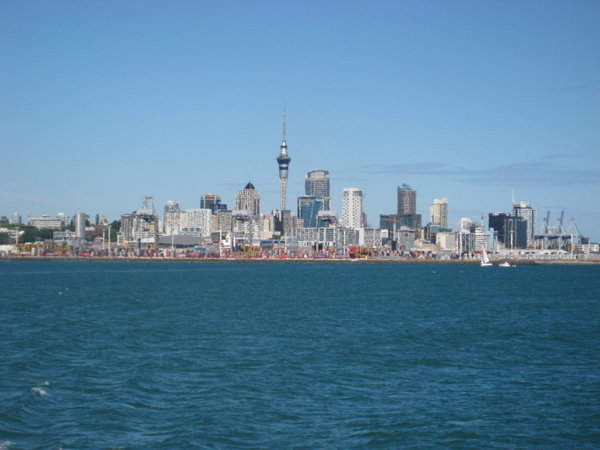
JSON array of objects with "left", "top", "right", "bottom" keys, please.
[{"left": 0, "top": 262, "right": 600, "bottom": 449}]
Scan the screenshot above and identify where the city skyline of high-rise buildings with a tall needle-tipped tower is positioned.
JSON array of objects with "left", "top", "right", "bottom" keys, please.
[{"left": 0, "top": 119, "right": 587, "bottom": 255}]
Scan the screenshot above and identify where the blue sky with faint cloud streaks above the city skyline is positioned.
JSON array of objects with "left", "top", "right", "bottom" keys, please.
[{"left": 0, "top": 0, "right": 600, "bottom": 241}]
